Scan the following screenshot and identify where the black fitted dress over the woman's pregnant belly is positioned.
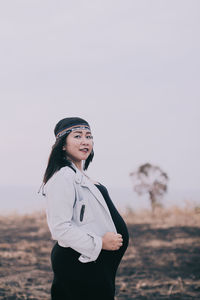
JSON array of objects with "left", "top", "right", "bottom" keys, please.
[{"left": 51, "top": 185, "right": 129, "bottom": 300}]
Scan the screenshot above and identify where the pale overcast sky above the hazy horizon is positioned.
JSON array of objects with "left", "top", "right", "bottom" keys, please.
[{"left": 0, "top": 0, "right": 200, "bottom": 189}]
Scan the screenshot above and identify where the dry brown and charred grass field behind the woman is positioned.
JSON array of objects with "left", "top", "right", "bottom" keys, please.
[{"left": 0, "top": 208, "right": 200, "bottom": 300}]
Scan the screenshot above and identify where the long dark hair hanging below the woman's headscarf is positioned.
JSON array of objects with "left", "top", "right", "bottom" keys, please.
[{"left": 43, "top": 133, "right": 94, "bottom": 184}]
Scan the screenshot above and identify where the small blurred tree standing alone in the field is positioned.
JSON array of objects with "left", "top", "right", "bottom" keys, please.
[{"left": 130, "top": 163, "right": 169, "bottom": 211}]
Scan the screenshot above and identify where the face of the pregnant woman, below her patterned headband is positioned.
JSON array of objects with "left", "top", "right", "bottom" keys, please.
[{"left": 63, "top": 129, "right": 93, "bottom": 163}]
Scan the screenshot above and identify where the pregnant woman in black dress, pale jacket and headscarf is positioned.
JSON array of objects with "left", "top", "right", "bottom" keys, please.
[{"left": 43, "top": 117, "right": 128, "bottom": 300}]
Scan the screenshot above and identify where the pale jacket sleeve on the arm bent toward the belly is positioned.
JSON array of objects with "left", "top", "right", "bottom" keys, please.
[{"left": 45, "top": 172, "right": 102, "bottom": 263}]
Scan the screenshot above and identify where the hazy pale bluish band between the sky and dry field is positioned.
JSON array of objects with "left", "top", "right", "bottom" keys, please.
[{"left": 0, "top": 186, "right": 200, "bottom": 214}]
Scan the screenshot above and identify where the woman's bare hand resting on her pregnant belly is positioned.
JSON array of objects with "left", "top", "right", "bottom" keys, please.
[{"left": 102, "top": 232, "right": 123, "bottom": 250}]
